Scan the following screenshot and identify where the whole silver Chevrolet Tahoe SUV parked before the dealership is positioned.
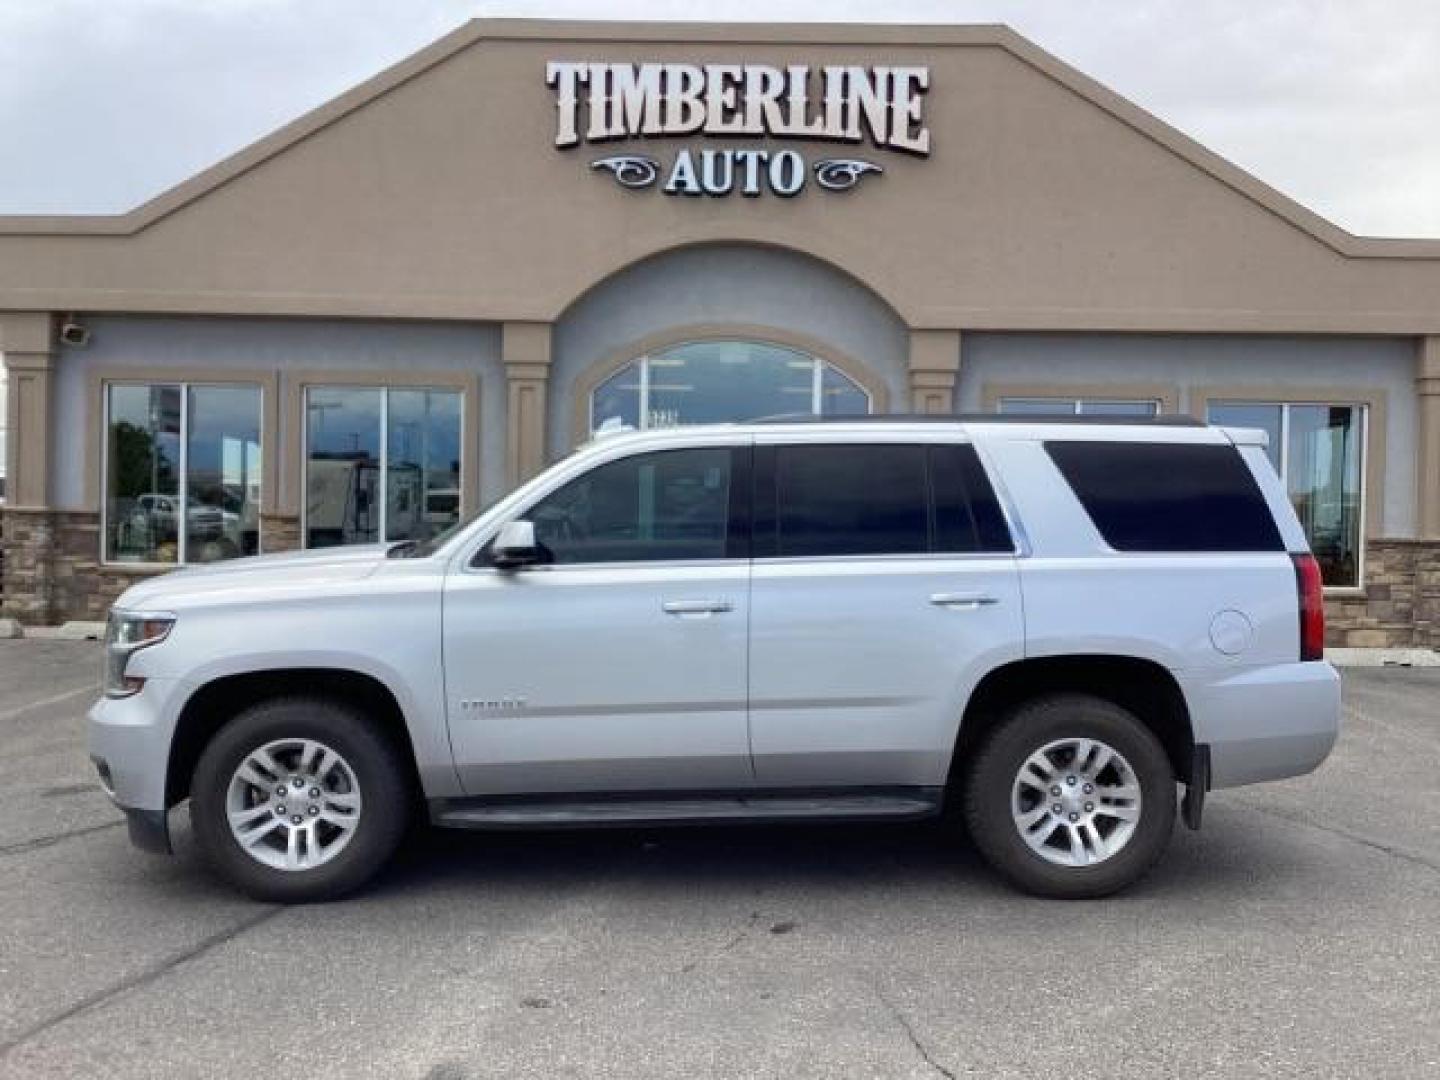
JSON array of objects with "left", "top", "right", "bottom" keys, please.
[{"left": 91, "top": 418, "right": 1339, "bottom": 900}]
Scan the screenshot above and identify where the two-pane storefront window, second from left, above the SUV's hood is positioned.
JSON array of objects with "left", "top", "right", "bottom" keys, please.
[{"left": 305, "top": 386, "right": 461, "bottom": 547}]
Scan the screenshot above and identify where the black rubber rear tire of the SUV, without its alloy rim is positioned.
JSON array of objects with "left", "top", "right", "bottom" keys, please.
[{"left": 965, "top": 694, "right": 1175, "bottom": 900}]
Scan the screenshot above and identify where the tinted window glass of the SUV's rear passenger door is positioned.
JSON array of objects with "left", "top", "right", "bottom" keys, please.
[{"left": 755, "top": 444, "right": 1014, "bottom": 559}]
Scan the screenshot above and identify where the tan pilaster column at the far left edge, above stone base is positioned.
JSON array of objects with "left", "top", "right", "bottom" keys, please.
[{"left": 0, "top": 311, "right": 55, "bottom": 510}]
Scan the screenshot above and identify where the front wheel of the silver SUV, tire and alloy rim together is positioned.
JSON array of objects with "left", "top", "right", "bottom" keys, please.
[{"left": 190, "top": 697, "right": 410, "bottom": 903}]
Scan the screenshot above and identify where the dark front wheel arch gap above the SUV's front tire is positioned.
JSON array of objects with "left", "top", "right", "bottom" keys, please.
[{"left": 166, "top": 667, "right": 420, "bottom": 806}]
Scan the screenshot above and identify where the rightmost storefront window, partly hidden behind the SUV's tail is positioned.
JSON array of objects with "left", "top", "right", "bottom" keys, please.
[{"left": 1210, "top": 402, "right": 1365, "bottom": 586}]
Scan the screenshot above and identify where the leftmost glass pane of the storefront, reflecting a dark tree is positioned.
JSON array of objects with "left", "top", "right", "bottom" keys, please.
[{"left": 105, "top": 386, "right": 180, "bottom": 563}]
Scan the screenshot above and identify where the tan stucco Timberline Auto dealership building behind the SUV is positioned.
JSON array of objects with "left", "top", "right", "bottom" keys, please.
[{"left": 0, "top": 20, "right": 1440, "bottom": 648}]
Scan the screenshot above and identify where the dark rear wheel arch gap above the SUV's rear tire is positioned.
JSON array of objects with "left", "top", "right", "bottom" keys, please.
[{"left": 949, "top": 654, "right": 1195, "bottom": 780}]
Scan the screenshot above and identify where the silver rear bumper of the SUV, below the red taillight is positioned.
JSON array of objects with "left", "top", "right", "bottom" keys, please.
[{"left": 1178, "top": 661, "right": 1341, "bottom": 788}]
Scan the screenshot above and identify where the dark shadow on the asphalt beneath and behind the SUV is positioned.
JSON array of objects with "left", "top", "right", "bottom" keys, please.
[{"left": 345, "top": 808, "right": 1335, "bottom": 907}]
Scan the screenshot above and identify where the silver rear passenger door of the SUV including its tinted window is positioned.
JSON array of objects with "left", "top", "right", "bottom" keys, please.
[{"left": 750, "top": 438, "right": 1024, "bottom": 786}]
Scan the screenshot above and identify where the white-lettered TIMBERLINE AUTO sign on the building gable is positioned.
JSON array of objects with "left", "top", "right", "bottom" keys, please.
[{"left": 546, "top": 60, "right": 930, "bottom": 197}]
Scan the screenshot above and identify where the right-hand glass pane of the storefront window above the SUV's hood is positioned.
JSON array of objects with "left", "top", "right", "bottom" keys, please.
[{"left": 384, "top": 390, "right": 459, "bottom": 540}]
